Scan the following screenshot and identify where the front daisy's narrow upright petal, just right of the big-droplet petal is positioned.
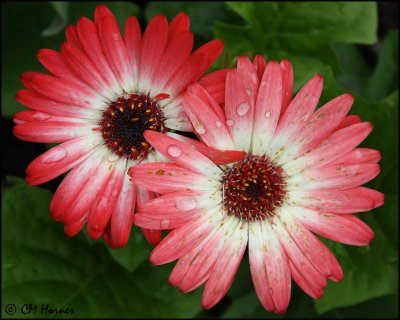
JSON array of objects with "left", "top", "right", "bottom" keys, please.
[{"left": 252, "top": 61, "right": 282, "bottom": 155}]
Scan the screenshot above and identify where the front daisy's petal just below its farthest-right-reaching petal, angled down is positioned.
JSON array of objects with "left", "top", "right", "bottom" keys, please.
[{"left": 292, "top": 207, "right": 374, "bottom": 246}]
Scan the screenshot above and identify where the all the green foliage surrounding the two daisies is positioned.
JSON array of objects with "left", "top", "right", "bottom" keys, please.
[{"left": 2, "top": 1, "right": 398, "bottom": 318}]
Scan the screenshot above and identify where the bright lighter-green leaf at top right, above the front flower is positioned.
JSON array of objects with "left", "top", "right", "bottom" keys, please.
[{"left": 215, "top": 2, "right": 377, "bottom": 67}]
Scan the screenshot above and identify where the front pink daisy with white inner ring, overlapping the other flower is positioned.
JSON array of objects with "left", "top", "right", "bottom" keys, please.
[{"left": 129, "top": 56, "right": 383, "bottom": 313}]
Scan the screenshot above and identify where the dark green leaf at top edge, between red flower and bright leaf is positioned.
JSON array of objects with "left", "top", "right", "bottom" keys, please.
[{"left": 145, "top": 1, "right": 240, "bottom": 40}]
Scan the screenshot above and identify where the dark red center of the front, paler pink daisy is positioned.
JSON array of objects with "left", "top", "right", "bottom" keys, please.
[{"left": 223, "top": 155, "right": 286, "bottom": 221}]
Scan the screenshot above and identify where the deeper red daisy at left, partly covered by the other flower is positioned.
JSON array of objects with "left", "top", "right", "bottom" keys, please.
[{"left": 14, "top": 6, "right": 231, "bottom": 247}]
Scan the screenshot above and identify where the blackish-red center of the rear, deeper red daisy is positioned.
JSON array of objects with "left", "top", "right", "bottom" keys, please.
[{"left": 100, "top": 94, "right": 168, "bottom": 160}]
